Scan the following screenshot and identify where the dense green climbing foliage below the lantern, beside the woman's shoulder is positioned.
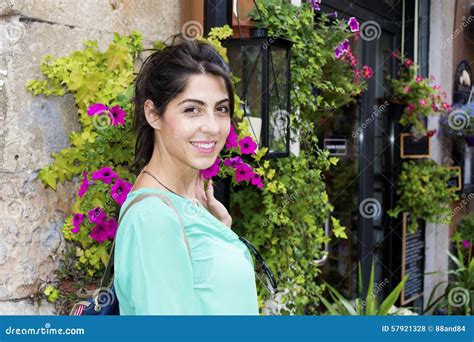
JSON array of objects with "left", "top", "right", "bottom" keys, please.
[{"left": 231, "top": 123, "right": 347, "bottom": 314}]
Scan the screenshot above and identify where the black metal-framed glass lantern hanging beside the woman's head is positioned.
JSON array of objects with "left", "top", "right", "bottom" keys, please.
[{"left": 222, "top": 30, "right": 293, "bottom": 158}]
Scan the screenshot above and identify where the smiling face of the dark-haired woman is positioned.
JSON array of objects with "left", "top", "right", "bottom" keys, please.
[{"left": 149, "top": 74, "right": 230, "bottom": 170}]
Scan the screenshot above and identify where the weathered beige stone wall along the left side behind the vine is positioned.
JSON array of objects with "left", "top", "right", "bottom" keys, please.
[{"left": 0, "top": 0, "right": 180, "bottom": 315}]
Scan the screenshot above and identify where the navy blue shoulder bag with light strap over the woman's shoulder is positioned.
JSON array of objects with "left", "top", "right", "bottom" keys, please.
[{"left": 69, "top": 193, "right": 191, "bottom": 316}]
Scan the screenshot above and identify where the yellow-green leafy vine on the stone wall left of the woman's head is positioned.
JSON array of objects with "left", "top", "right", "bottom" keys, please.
[{"left": 27, "top": 32, "right": 143, "bottom": 189}]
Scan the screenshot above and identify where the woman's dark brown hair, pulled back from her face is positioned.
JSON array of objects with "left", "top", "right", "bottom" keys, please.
[{"left": 133, "top": 34, "right": 234, "bottom": 173}]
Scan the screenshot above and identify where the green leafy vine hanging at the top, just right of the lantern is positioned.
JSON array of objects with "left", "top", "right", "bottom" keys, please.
[{"left": 249, "top": 0, "right": 366, "bottom": 122}]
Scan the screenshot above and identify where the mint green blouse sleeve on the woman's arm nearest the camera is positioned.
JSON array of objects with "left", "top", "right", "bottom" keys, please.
[{"left": 124, "top": 198, "right": 195, "bottom": 315}]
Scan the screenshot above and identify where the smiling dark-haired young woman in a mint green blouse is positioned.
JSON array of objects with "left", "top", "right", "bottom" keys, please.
[{"left": 114, "top": 37, "right": 259, "bottom": 315}]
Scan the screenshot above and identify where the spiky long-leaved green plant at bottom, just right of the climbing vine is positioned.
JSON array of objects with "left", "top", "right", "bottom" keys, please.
[{"left": 318, "top": 261, "right": 408, "bottom": 316}]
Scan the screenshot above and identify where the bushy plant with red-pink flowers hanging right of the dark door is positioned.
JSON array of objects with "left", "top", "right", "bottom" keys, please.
[{"left": 389, "top": 52, "right": 451, "bottom": 137}]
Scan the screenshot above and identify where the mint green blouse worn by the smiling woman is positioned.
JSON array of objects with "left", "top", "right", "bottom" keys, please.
[{"left": 114, "top": 188, "right": 259, "bottom": 315}]
